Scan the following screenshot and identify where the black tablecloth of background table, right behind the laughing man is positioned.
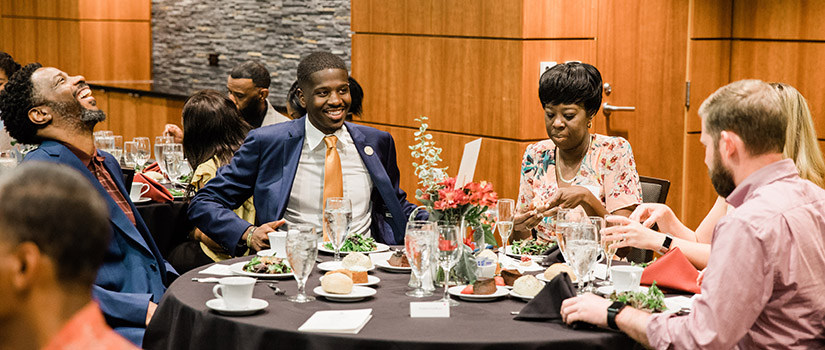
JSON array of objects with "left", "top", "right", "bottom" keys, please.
[{"left": 135, "top": 200, "right": 193, "bottom": 258}]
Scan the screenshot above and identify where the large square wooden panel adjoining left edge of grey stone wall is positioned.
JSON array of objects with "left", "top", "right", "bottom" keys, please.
[{"left": 80, "top": 21, "right": 152, "bottom": 81}]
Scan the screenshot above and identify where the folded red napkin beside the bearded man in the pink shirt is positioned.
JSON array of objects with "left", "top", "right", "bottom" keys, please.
[{"left": 642, "top": 247, "right": 702, "bottom": 294}]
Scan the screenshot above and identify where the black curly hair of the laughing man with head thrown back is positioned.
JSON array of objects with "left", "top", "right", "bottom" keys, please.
[{"left": 0, "top": 63, "right": 45, "bottom": 144}]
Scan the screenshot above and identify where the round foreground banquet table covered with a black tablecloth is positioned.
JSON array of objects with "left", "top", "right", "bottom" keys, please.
[{"left": 143, "top": 254, "right": 638, "bottom": 350}]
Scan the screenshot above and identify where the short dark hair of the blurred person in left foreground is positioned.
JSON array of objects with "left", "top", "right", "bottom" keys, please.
[{"left": 0, "top": 162, "right": 111, "bottom": 288}]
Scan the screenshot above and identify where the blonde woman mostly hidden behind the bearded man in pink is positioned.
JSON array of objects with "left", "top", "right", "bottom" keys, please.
[{"left": 603, "top": 83, "right": 825, "bottom": 269}]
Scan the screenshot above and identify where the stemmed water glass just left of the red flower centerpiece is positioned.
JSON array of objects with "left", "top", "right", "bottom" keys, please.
[{"left": 404, "top": 220, "right": 437, "bottom": 298}]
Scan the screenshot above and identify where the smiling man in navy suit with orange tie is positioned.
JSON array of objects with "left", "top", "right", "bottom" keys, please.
[{"left": 189, "top": 52, "right": 426, "bottom": 255}]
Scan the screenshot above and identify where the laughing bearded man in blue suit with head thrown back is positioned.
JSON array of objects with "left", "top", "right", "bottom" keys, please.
[{"left": 0, "top": 63, "right": 177, "bottom": 346}]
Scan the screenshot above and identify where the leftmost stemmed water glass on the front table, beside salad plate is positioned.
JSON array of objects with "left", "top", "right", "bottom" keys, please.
[{"left": 286, "top": 225, "right": 318, "bottom": 303}]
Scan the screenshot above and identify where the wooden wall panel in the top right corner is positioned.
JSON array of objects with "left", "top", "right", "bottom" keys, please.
[{"left": 733, "top": 0, "right": 825, "bottom": 40}]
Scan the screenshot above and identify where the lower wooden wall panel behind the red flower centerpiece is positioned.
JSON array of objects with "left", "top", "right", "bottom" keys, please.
[{"left": 361, "top": 123, "right": 530, "bottom": 203}]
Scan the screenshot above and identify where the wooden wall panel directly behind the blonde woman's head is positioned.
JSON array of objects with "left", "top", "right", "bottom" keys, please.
[{"left": 731, "top": 41, "right": 825, "bottom": 137}]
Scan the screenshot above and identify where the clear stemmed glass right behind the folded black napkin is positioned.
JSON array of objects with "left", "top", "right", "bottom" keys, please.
[{"left": 563, "top": 222, "right": 601, "bottom": 295}]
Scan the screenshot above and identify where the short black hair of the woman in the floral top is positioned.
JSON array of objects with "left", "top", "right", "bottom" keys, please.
[{"left": 539, "top": 62, "right": 602, "bottom": 117}]
